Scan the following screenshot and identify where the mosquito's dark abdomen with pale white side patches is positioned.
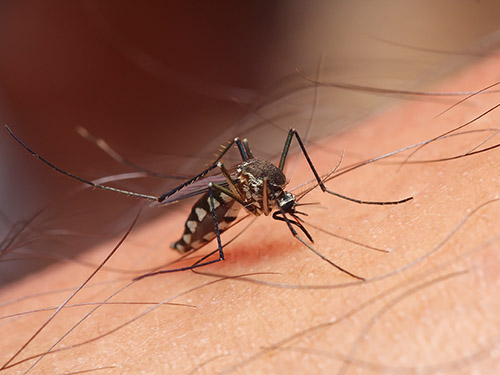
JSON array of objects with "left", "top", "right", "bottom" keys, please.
[{"left": 170, "top": 190, "right": 241, "bottom": 253}]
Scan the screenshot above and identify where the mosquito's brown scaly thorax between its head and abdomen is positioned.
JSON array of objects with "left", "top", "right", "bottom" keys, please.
[{"left": 236, "top": 159, "right": 287, "bottom": 215}]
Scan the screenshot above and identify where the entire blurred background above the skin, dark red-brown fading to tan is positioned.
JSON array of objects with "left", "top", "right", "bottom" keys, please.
[{"left": 0, "top": 0, "right": 500, "bottom": 282}]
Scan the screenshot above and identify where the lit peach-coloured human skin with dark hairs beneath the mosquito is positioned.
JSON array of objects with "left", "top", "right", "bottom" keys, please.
[{"left": 1, "top": 53, "right": 500, "bottom": 374}]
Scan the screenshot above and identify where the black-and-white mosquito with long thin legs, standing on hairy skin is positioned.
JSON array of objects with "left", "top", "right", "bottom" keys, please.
[{"left": 5, "top": 125, "right": 413, "bottom": 280}]
